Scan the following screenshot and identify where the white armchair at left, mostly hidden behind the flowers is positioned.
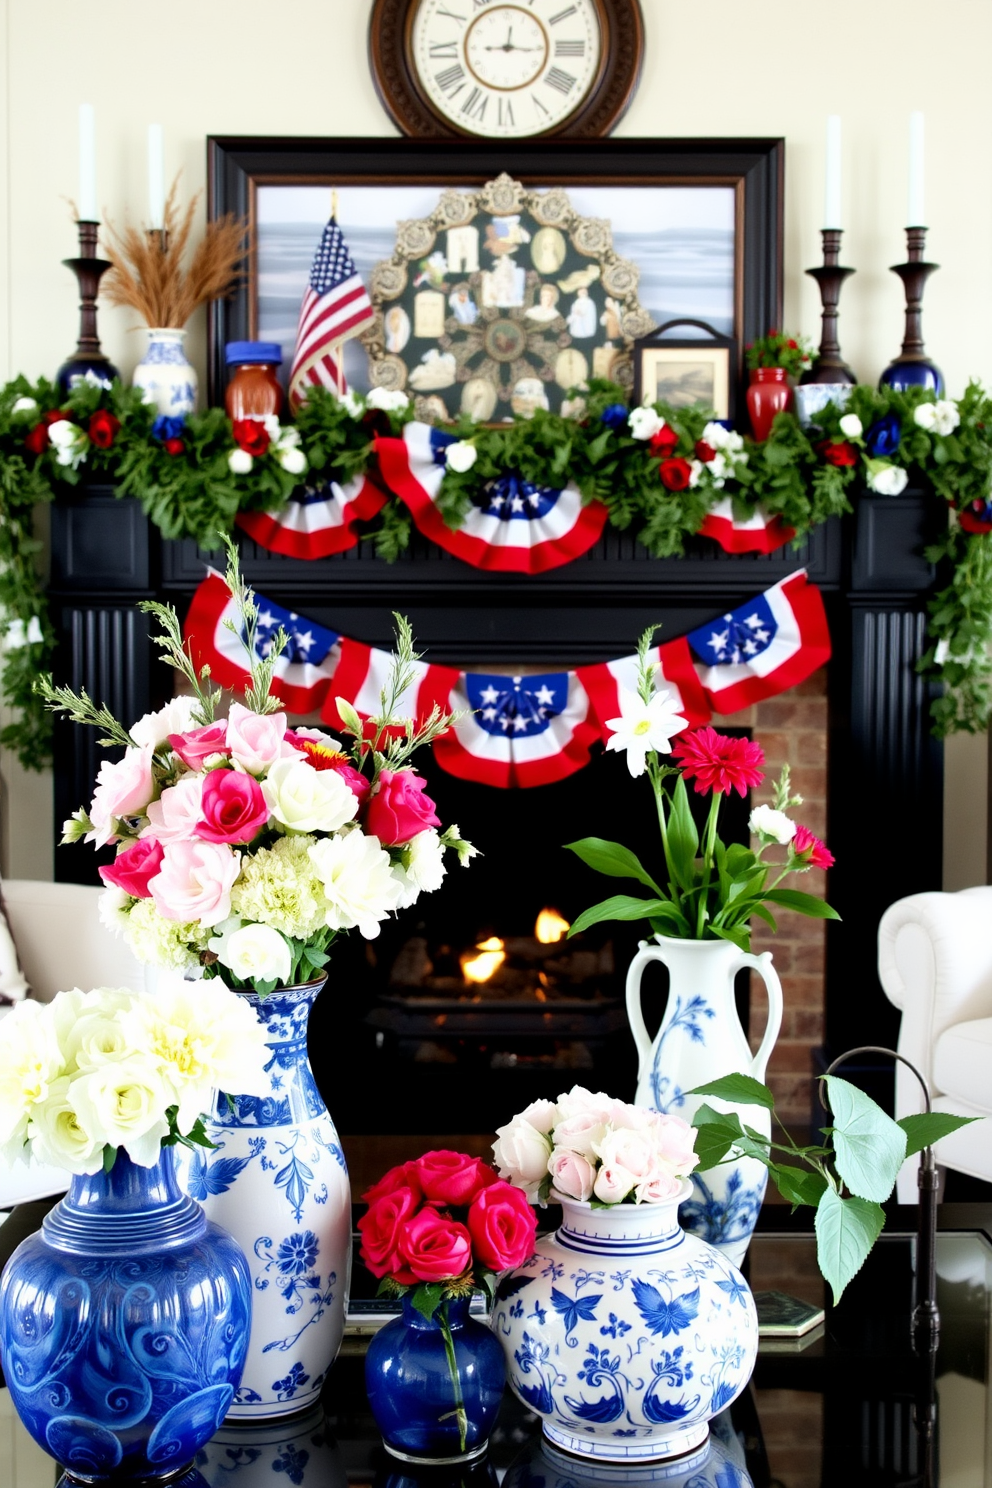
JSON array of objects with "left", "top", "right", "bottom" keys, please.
[{"left": 0, "top": 878, "right": 147, "bottom": 1210}]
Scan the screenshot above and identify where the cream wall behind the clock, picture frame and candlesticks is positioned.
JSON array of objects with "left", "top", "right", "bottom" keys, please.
[{"left": 0, "top": 0, "right": 992, "bottom": 887}]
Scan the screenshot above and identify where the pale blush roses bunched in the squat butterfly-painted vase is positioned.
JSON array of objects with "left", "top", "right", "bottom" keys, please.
[{"left": 492, "top": 1085, "right": 699, "bottom": 1208}]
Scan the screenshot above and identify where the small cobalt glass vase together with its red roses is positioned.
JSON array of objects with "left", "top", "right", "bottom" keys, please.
[{"left": 358, "top": 1150, "right": 537, "bottom": 1464}]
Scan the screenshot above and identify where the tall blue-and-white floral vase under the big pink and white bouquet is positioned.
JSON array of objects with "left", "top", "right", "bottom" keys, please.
[{"left": 186, "top": 978, "right": 351, "bottom": 1421}]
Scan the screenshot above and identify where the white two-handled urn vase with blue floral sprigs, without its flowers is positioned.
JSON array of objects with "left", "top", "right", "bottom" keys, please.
[{"left": 626, "top": 936, "right": 782, "bottom": 1266}]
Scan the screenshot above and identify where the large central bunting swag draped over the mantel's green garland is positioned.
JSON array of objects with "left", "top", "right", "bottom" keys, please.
[{"left": 375, "top": 423, "right": 610, "bottom": 573}]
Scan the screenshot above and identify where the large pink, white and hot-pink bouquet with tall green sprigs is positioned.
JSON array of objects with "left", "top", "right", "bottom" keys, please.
[{"left": 39, "top": 548, "right": 474, "bottom": 992}]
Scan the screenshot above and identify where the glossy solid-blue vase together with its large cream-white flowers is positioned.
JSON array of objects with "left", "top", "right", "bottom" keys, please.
[{"left": 0, "top": 982, "right": 269, "bottom": 1482}]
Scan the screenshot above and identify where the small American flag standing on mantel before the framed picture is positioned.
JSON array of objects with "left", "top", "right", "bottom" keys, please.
[{"left": 290, "top": 217, "right": 375, "bottom": 408}]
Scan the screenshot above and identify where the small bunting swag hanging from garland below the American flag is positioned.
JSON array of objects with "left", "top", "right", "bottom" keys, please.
[{"left": 238, "top": 475, "right": 388, "bottom": 558}]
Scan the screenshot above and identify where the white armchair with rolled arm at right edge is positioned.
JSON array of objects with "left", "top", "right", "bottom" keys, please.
[{"left": 879, "top": 887, "right": 992, "bottom": 1204}]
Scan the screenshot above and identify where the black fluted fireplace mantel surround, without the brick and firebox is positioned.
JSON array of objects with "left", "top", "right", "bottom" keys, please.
[{"left": 49, "top": 487, "right": 943, "bottom": 1048}]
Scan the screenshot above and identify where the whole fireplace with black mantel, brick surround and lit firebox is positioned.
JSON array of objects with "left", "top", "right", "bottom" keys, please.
[{"left": 51, "top": 487, "right": 943, "bottom": 1132}]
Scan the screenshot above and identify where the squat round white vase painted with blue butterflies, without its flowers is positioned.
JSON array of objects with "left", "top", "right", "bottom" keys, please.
[{"left": 492, "top": 1181, "right": 759, "bottom": 1464}]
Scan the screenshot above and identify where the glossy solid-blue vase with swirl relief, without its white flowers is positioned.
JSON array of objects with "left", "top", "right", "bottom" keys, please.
[{"left": 0, "top": 1147, "right": 251, "bottom": 1484}]
